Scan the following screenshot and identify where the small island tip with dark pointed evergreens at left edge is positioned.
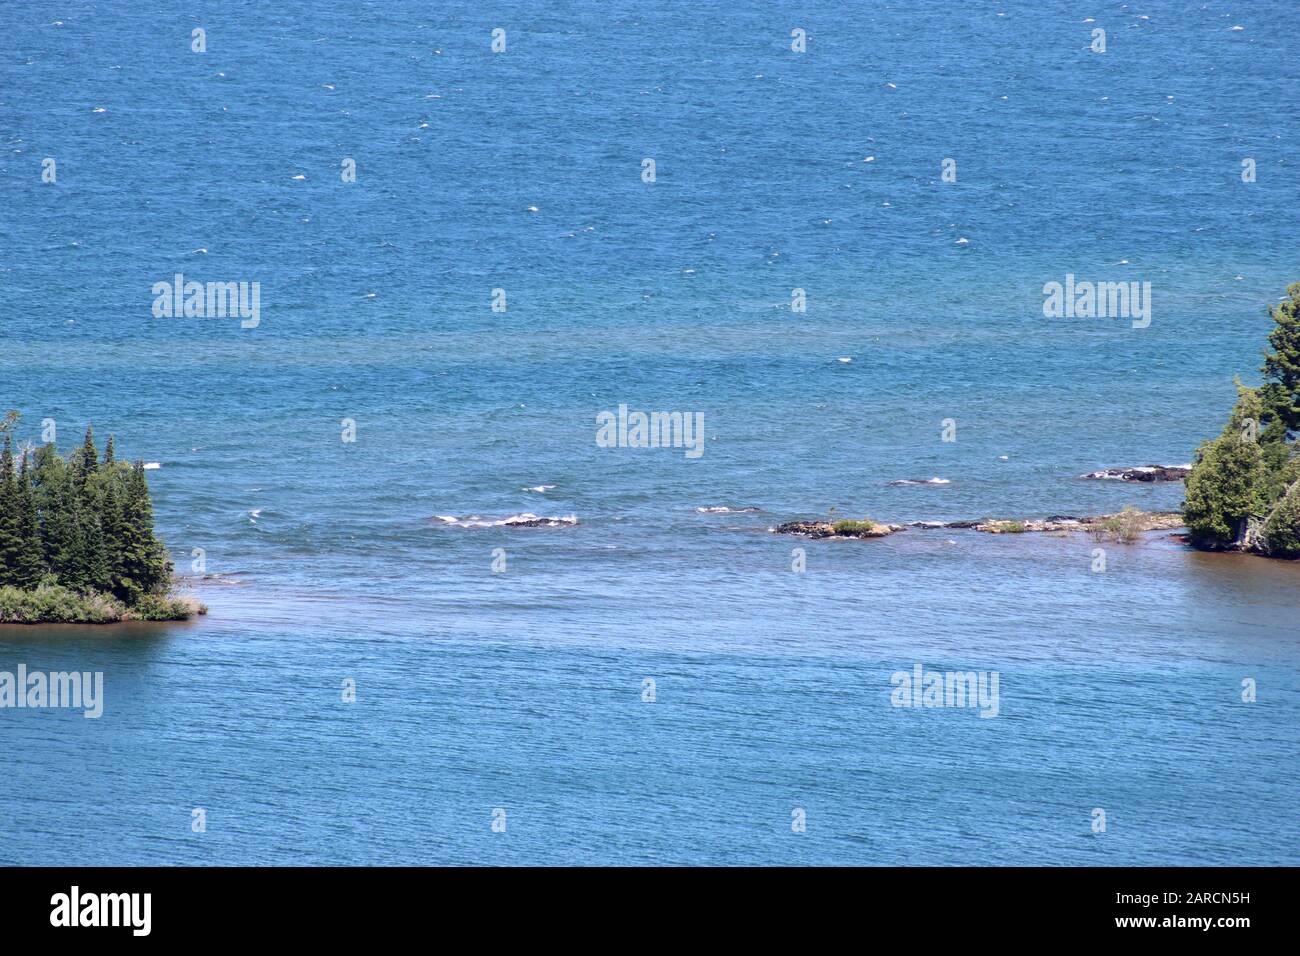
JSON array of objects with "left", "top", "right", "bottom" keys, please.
[{"left": 0, "top": 412, "right": 207, "bottom": 624}]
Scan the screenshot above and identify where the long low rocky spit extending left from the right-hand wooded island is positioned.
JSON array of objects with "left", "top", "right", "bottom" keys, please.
[{"left": 771, "top": 510, "right": 1183, "bottom": 538}]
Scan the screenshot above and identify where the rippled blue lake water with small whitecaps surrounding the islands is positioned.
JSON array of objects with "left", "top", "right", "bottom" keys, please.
[{"left": 0, "top": 0, "right": 1300, "bottom": 865}]
